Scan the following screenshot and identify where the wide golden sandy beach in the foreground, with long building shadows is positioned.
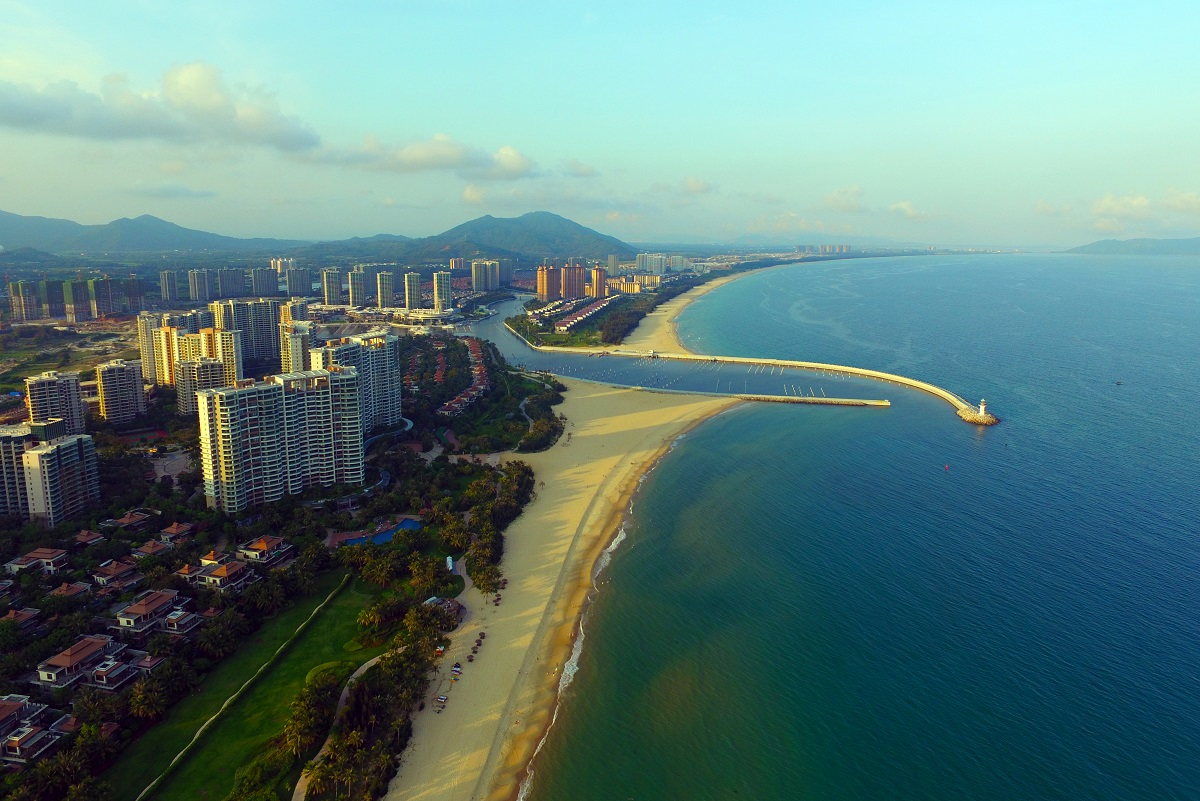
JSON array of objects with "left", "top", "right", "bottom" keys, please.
[{"left": 388, "top": 378, "right": 737, "bottom": 801}]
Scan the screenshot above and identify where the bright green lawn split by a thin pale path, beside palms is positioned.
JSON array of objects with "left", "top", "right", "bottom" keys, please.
[{"left": 103, "top": 571, "right": 383, "bottom": 801}]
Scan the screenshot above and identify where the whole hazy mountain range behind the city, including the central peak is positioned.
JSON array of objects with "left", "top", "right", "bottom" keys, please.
[{"left": 0, "top": 211, "right": 636, "bottom": 264}]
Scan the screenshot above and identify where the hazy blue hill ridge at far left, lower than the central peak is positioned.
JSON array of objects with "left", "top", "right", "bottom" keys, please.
[{"left": 0, "top": 211, "right": 305, "bottom": 253}]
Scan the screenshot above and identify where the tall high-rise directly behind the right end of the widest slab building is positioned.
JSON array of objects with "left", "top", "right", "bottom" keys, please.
[{"left": 310, "top": 329, "right": 404, "bottom": 432}]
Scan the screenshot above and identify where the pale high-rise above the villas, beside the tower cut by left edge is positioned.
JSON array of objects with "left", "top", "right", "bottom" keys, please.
[{"left": 20, "top": 434, "right": 100, "bottom": 529}]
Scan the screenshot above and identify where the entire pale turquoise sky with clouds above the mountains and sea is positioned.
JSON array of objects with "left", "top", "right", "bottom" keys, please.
[{"left": 0, "top": 0, "right": 1200, "bottom": 247}]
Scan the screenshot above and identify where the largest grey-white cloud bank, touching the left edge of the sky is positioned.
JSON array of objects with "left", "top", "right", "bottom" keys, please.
[{"left": 0, "top": 61, "right": 320, "bottom": 152}]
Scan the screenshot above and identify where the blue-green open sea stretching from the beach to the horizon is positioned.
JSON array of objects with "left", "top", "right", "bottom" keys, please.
[{"left": 528, "top": 255, "right": 1200, "bottom": 801}]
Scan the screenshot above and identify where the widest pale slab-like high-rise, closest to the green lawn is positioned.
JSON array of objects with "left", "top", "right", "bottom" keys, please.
[{"left": 197, "top": 368, "right": 364, "bottom": 512}]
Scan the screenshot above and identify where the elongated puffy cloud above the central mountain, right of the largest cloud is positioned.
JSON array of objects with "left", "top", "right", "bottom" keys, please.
[{"left": 307, "top": 133, "right": 534, "bottom": 181}]
